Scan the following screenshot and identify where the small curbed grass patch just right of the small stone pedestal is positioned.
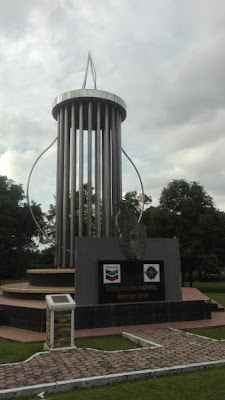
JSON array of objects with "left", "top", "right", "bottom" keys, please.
[{"left": 75, "top": 335, "right": 140, "bottom": 351}]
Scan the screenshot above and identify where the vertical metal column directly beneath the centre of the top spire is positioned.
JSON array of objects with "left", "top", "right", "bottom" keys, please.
[{"left": 87, "top": 101, "right": 92, "bottom": 237}]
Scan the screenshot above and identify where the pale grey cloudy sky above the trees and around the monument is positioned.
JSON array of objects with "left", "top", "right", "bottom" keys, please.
[{"left": 0, "top": 0, "right": 225, "bottom": 211}]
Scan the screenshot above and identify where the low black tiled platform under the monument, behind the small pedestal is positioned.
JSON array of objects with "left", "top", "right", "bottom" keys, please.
[{"left": 0, "top": 292, "right": 212, "bottom": 332}]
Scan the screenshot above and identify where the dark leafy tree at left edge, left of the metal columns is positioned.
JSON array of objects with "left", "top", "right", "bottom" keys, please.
[{"left": 0, "top": 176, "right": 43, "bottom": 278}]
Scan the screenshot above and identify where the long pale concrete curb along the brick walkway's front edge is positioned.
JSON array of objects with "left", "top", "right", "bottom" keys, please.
[{"left": 0, "top": 359, "right": 225, "bottom": 400}]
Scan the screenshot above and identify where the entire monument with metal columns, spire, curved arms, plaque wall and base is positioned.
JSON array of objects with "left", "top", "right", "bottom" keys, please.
[{"left": 1, "top": 52, "right": 211, "bottom": 330}]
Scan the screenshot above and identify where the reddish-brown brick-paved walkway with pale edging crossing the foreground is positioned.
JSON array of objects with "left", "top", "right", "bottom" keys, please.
[{"left": 0, "top": 329, "right": 225, "bottom": 399}]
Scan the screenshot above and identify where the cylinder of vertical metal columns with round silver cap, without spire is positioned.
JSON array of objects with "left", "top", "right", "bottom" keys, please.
[{"left": 52, "top": 89, "right": 126, "bottom": 268}]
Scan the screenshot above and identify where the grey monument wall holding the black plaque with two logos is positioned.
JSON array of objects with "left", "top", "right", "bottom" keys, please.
[{"left": 75, "top": 237, "right": 182, "bottom": 306}]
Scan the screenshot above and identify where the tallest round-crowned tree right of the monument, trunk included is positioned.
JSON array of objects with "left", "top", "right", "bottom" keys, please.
[{"left": 160, "top": 179, "right": 220, "bottom": 286}]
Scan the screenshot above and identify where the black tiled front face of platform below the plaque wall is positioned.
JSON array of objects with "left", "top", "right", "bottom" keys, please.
[{"left": 75, "top": 300, "right": 211, "bottom": 329}]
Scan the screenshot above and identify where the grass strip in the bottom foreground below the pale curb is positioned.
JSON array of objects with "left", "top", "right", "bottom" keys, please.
[{"left": 11, "top": 368, "right": 225, "bottom": 400}]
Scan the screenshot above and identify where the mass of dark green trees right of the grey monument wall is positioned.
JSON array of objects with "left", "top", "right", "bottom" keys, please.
[{"left": 144, "top": 179, "right": 225, "bottom": 284}]
